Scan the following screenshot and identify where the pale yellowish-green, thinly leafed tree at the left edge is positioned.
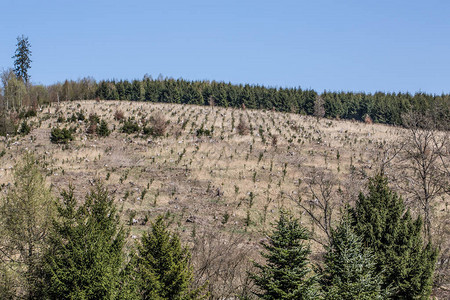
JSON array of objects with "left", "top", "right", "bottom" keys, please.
[{"left": 0, "top": 154, "right": 54, "bottom": 298}]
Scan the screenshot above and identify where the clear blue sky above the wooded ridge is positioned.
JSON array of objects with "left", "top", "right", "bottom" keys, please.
[{"left": 0, "top": 0, "right": 450, "bottom": 94}]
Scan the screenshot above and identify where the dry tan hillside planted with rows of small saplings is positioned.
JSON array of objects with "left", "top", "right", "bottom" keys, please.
[{"left": 0, "top": 101, "right": 446, "bottom": 298}]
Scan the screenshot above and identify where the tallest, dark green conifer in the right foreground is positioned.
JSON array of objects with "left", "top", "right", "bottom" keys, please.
[{"left": 351, "top": 175, "right": 437, "bottom": 299}]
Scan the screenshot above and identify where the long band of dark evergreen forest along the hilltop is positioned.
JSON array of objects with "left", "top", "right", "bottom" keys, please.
[{"left": 4, "top": 76, "right": 450, "bottom": 125}]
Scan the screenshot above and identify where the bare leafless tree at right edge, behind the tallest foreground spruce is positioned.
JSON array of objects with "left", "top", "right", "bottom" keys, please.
[{"left": 399, "top": 113, "right": 450, "bottom": 241}]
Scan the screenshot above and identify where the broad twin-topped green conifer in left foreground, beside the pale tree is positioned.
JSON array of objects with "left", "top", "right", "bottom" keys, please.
[{"left": 40, "top": 184, "right": 132, "bottom": 299}]
